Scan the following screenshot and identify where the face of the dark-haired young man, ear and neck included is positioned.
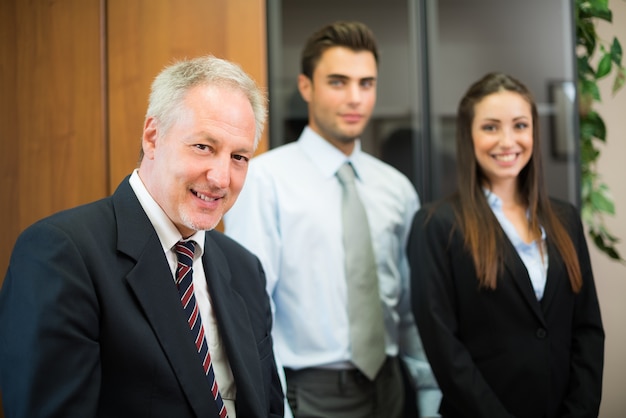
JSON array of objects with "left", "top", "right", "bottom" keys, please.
[{"left": 298, "top": 47, "right": 378, "bottom": 154}]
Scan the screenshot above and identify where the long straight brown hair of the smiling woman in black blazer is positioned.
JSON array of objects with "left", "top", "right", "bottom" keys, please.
[{"left": 456, "top": 73, "right": 582, "bottom": 293}]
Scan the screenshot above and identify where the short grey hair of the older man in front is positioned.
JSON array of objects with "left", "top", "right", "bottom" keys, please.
[{"left": 146, "top": 55, "right": 267, "bottom": 149}]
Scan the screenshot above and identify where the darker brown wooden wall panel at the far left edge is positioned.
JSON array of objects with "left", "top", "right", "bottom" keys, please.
[{"left": 0, "top": 0, "right": 108, "bottom": 280}]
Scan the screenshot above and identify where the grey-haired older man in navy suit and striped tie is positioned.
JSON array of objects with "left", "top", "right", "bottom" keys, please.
[{"left": 0, "top": 56, "right": 283, "bottom": 418}]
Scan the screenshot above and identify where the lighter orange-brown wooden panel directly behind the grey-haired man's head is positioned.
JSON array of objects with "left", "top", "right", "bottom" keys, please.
[{"left": 107, "top": 0, "right": 267, "bottom": 192}]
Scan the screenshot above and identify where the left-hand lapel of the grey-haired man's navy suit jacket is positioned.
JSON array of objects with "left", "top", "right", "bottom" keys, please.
[{"left": 113, "top": 179, "right": 219, "bottom": 417}]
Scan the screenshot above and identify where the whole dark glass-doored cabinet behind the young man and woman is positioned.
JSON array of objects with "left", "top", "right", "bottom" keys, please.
[{"left": 267, "top": 0, "right": 579, "bottom": 204}]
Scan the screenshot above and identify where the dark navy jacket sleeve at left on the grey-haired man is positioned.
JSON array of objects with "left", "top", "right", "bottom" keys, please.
[{"left": 0, "top": 222, "right": 101, "bottom": 417}]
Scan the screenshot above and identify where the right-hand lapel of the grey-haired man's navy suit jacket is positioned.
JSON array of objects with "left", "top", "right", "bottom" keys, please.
[{"left": 203, "top": 232, "right": 263, "bottom": 416}]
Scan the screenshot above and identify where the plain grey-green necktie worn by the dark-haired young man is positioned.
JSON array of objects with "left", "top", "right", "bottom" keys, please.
[{"left": 337, "top": 163, "right": 386, "bottom": 380}]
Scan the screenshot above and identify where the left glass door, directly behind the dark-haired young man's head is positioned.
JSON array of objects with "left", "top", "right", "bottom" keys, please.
[{"left": 267, "top": 0, "right": 424, "bottom": 198}]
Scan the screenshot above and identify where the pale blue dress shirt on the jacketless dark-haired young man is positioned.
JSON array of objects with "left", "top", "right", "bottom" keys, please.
[{"left": 224, "top": 127, "right": 436, "bottom": 387}]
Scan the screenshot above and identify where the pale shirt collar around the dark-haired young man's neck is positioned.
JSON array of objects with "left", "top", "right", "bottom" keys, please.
[{"left": 298, "top": 126, "right": 364, "bottom": 179}]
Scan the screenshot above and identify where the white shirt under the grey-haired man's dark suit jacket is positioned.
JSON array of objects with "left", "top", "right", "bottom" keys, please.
[{"left": 129, "top": 170, "right": 237, "bottom": 418}]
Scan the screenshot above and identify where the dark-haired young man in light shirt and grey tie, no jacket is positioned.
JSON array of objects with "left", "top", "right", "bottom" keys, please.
[{"left": 225, "top": 22, "right": 436, "bottom": 418}]
